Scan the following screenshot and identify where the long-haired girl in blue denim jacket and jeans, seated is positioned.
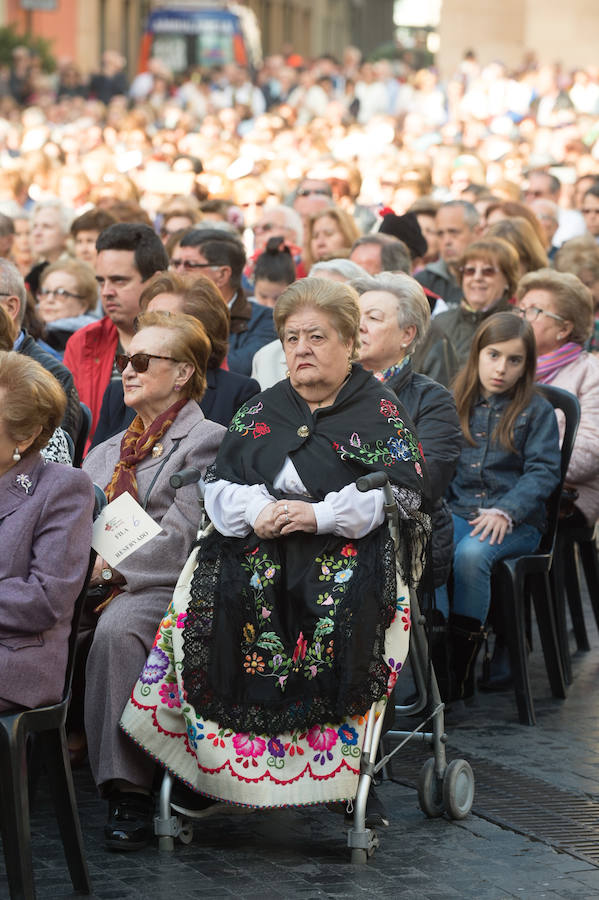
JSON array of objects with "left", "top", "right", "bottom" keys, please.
[{"left": 447, "top": 312, "right": 560, "bottom": 698}]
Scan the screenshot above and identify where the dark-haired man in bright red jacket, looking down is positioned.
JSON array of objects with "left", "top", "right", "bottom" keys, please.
[{"left": 64, "top": 223, "right": 168, "bottom": 446}]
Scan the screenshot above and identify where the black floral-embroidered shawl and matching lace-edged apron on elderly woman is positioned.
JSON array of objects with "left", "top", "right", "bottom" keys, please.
[{"left": 182, "top": 366, "right": 426, "bottom": 735}]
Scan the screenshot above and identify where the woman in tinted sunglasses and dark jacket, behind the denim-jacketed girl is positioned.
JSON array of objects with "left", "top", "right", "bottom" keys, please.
[{"left": 435, "top": 238, "right": 518, "bottom": 366}]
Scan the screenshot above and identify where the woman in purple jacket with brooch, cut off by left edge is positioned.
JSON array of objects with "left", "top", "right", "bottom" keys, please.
[{"left": 0, "top": 351, "right": 94, "bottom": 711}]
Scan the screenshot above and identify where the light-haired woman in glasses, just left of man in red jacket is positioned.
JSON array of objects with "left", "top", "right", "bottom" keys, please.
[{"left": 36, "top": 259, "right": 98, "bottom": 356}]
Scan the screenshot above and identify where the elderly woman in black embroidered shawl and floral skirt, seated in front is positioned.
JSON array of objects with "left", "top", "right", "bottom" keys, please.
[{"left": 121, "top": 278, "right": 429, "bottom": 824}]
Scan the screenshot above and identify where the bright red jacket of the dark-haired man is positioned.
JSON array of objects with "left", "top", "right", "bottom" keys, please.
[{"left": 63, "top": 316, "right": 119, "bottom": 447}]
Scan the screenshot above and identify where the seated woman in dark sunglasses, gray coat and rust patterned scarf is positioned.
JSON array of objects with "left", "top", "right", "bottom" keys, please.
[{"left": 79, "top": 312, "right": 225, "bottom": 849}]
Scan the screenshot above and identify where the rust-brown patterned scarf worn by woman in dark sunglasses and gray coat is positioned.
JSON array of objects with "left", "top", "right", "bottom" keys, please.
[{"left": 94, "top": 397, "right": 188, "bottom": 613}]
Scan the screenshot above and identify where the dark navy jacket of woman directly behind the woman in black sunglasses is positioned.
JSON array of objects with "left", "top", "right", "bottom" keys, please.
[{"left": 92, "top": 369, "right": 260, "bottom": 447}]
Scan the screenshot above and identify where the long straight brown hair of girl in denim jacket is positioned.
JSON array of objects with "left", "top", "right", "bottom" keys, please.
[{"left": 453, "top": 312, "right": 537, "bottom": 453}]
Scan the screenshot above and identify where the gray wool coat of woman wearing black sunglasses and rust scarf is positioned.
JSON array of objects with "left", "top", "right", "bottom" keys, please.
[{"left": 83, "top": 401, "right": 226, "bottom": 787}]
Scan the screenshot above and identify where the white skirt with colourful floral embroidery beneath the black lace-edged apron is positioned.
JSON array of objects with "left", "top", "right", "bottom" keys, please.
[{"left": 120, "top": 536, "right": 410, "bottom": 807}]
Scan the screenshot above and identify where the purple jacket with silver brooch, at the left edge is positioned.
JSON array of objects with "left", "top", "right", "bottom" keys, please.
[{"left": 0, "top": 453, "right": 94, "bottom": 707}]
